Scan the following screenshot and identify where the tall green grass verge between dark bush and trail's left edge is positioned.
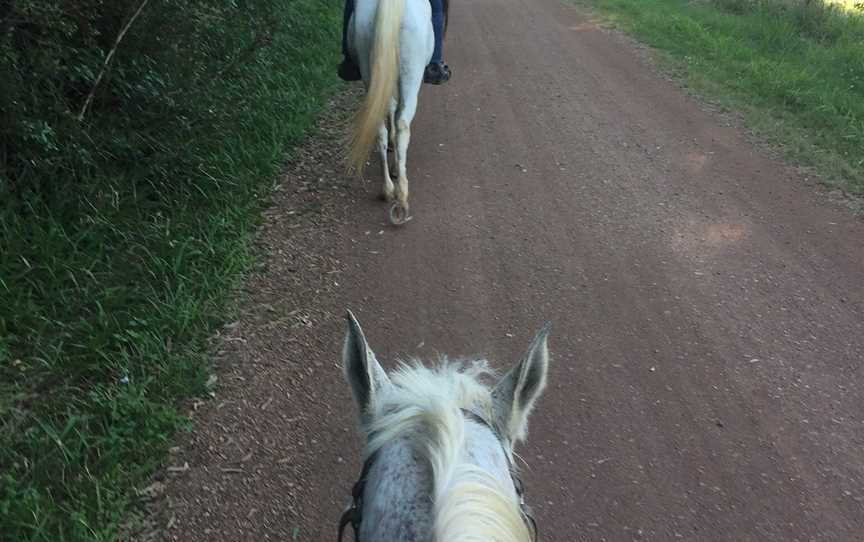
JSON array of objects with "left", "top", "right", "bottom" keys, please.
[{"left": 0, "top": 0, "right": 340, "bottom": 542}]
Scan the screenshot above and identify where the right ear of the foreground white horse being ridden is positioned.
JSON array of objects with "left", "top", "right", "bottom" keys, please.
[{"left": 492, "top": 323, "right": 551, "bottom": 442}]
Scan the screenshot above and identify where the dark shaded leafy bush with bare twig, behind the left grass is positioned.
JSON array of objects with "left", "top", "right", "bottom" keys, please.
[{"left": 0, "top": 0, "right": 298, "bottom": 208}]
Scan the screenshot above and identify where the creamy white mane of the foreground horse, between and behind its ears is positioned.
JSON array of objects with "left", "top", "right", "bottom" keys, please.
[{"left": 364, "top": 358, "right": 530, "bottom": 542}]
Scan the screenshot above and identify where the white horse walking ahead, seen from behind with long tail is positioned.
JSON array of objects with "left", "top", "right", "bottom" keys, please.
[{"left": 348, "top": 0, "right": 435, "bottom": 224}]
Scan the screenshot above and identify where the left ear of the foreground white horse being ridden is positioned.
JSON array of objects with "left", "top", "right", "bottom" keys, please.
[{"left": 342, "top": 311, "right": 390, "bottom": 420}]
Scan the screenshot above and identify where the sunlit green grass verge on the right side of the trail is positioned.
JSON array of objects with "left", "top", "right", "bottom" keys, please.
[{"left": 576, "top": 0, "right": 864, "bottom": 195}]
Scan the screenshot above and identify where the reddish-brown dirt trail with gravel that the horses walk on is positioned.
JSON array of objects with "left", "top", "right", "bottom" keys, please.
[{"left": 142, "top": 0, "right": 864, "bottom": 541}]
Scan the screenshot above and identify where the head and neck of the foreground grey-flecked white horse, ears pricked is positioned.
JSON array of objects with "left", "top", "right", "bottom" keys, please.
[{"left": 339, "top": 312, "right": 549, "bottom": 542}]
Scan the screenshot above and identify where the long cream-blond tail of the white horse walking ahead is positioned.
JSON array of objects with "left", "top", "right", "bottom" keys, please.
[{"left": 348, "top": 0, "right": 405, "bottom": 171}]
